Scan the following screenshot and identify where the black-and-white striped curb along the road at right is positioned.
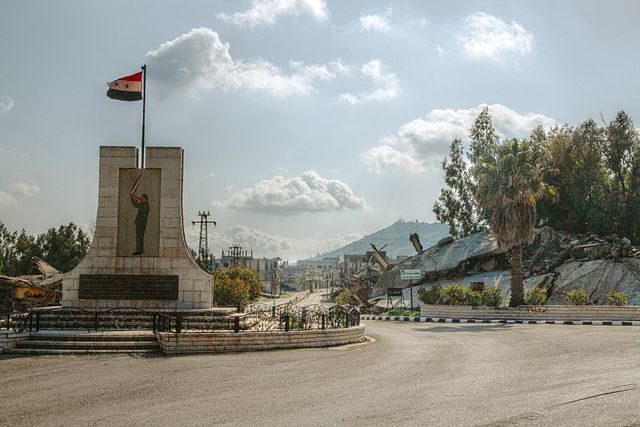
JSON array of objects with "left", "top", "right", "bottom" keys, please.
[{"left": 360, "top": 316, "right": 640, "bottom": 326}]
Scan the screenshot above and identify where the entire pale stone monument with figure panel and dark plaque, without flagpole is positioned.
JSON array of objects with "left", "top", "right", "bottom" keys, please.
[{"left": 62, "top": 147, "right": 213, "bottom": 310}]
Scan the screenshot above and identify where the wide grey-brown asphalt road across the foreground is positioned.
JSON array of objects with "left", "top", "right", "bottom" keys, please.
[{"left": 0, "top": 321, "right": 640, "bottom": 426}]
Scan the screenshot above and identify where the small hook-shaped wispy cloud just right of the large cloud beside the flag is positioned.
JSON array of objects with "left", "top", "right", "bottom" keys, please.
[{"left": 338, "top": 59, "right": 402, "bottom": 105}]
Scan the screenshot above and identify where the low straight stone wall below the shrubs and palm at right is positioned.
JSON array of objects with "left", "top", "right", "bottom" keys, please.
[{"left": 420, "top": 304, "right": 640, "bottom": 321}]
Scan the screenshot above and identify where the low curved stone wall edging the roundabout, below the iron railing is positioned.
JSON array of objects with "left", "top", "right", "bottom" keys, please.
[{"left": 157, "top": 325, "right": 365, "bottom": 355}]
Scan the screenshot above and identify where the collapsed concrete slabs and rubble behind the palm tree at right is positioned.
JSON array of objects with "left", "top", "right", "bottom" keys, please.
[{"left": 371, "top": 227, "right": 640, "bottom": 304}]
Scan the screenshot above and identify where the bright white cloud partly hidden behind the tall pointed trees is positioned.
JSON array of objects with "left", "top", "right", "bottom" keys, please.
[{"left": 360, "top": 104, "right": 556, "bottom": 173}]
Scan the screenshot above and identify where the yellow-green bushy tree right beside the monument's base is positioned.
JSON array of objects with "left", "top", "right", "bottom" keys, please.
[{"left": 213, "top": 265, "right": 263, "bottom": 306}]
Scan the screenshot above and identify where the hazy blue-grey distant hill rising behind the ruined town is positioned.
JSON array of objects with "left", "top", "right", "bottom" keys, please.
[{"left": 314, "top": 222, "right": 449, "bottom": 258}]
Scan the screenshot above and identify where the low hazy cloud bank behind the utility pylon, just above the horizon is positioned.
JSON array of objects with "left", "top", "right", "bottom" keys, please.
[{"left": 187, "top": 225, "right": 364, "bottom": 261}]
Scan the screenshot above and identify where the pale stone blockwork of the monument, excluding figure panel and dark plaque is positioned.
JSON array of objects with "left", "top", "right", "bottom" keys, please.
[{"left": 62, "top": 147, "right": 213, "bottom": 309}]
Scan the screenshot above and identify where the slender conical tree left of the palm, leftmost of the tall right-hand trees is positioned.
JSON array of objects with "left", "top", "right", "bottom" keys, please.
[{"left": 433, "top": 139, "right": 481, "bottom": 238}]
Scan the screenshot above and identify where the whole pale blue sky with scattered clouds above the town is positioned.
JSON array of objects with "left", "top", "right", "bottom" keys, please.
[{"left": 0, "top": 0, "right": 640, "bottom": 260}]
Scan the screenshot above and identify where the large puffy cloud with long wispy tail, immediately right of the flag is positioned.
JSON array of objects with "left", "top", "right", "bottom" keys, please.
[{"left": 146, "top": 27, "right": 349, "bottom": 97}]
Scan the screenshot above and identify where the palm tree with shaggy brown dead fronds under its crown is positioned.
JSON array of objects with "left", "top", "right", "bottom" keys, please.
[{"left": 472, "top": 138, "right": 558, "bottom": 307}]
